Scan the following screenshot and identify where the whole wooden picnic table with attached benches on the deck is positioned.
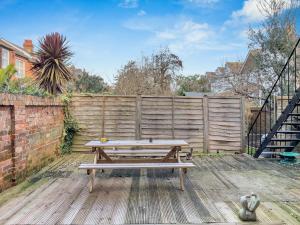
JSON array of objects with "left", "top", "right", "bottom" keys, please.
[{"left": 79, "top": 139, "right": 195, "bottom": 192}]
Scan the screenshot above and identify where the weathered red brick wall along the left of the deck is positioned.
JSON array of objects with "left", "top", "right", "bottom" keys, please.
[{"left": 0, "top": 94, "right": 64, "bottom": 191}]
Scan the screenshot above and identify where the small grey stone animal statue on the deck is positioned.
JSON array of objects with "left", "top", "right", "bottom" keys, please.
[{"left": 239, "top": 193, "right": 260, "bottom": 221}]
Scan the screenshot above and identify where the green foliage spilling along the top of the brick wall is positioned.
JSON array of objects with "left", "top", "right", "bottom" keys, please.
[{"left": 0, "top": 65, "right": 49, "bottom": 97}]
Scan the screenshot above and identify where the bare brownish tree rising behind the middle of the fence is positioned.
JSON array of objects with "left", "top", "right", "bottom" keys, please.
[{"left": 115, "top": 48, "right": 182, "bottom": 95}]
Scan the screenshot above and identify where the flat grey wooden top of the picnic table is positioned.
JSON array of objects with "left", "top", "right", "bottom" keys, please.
[{"left": 85, "top": 139, "right": 188, "bottom": 147}]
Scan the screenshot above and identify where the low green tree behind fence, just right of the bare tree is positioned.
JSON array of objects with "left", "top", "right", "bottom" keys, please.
[{"left": 176, "top": 75, "right": 210, "bottom": 96}]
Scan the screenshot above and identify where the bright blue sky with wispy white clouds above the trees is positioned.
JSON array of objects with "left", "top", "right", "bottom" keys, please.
[{"left": 0, "top": 0, "right": 300, "bottom": 83}]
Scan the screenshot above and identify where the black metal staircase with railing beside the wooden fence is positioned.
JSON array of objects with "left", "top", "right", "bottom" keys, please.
[{"left": 247, "top": 39, "right": 300, "bottom": 158}]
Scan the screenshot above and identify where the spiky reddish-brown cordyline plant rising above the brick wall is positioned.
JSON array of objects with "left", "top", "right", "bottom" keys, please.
[{"left": 32, "top": 33, "right": 73, "bottom": 95}]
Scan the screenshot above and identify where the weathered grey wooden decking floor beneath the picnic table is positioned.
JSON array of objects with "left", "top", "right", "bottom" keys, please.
[{"left": 0, "top": 154, "right": 300, "bottom": 225}]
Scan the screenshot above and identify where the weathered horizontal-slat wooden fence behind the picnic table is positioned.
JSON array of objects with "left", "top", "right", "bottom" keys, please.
[{"left": 69, "top": 95, "right": 244, "bottom": 152}]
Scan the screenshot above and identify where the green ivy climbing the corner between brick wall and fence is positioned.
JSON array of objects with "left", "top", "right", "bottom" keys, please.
[{"left": 60, "top": 94, "right": 79, "bottom": 154}]
